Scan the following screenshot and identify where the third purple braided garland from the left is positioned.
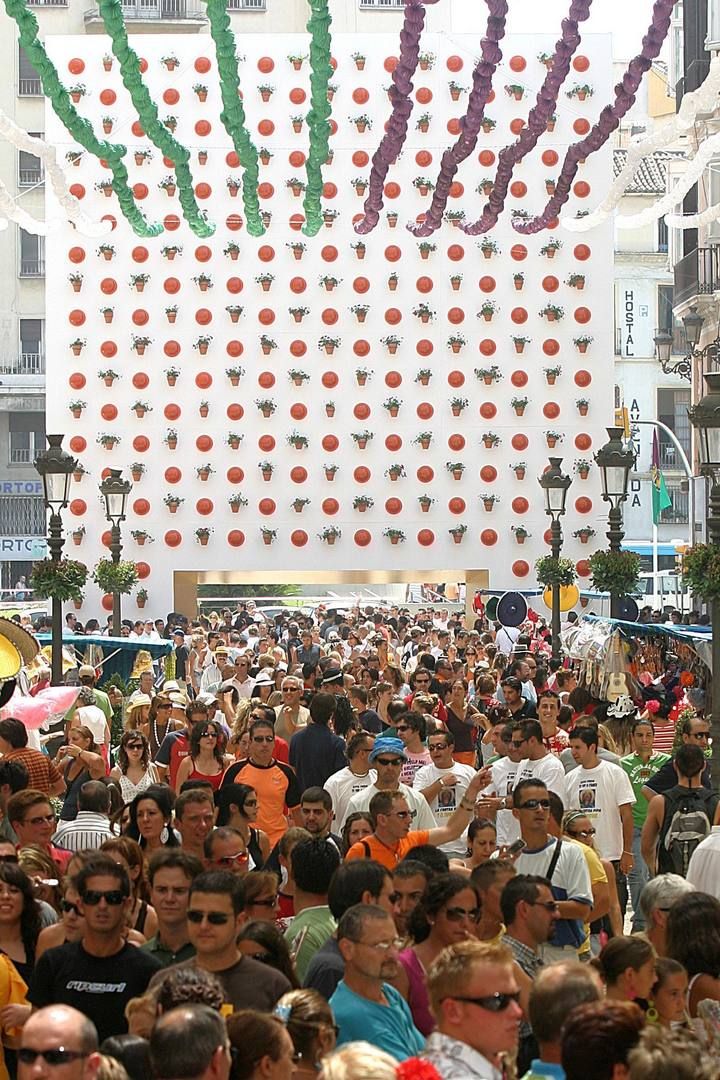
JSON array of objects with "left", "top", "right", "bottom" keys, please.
[{"left": 460, "top": 0, "right": 593, "bottom": 237}]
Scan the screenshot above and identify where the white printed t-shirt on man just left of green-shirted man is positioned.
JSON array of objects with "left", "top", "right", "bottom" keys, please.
[{"left": 565, "top": 760, "right": 635, "bottom": 862}]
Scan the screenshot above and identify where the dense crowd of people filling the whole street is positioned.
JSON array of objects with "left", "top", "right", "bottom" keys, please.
[{"left": 0, "top": 602, "right": 720, "bottom": 1080}]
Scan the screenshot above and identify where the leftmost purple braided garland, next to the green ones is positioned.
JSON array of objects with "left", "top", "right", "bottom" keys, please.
[{"left": 355, "top": 0, "right": 436, "bottom": 234}]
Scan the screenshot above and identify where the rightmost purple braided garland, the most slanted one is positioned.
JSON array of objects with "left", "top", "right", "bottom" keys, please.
[{"left": 513, "top": 0, "right": 675, "bottom": 235}]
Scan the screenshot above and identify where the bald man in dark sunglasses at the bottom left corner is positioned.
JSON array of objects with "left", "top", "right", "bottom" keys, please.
[{"left": 17, "top": 1005, "right": 100, "bottom": 1080}]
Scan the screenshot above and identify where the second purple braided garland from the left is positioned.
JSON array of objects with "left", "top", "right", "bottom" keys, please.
[{"left": 408, "top": 0, "right": 508, "bottom": 237}]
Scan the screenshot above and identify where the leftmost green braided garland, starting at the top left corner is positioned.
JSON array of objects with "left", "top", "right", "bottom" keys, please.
[{"left": 4, "top": 0, "right": 157, "bottom": 237}]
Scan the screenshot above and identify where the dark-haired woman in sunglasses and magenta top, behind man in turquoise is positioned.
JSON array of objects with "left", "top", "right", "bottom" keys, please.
[{"left": 392, "top": 874, "right": 480, "bottom": 1036}]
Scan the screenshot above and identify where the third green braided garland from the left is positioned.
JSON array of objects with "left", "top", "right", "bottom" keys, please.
[{"left": 206, "top": 0, "right": 266, "bottom": 237}]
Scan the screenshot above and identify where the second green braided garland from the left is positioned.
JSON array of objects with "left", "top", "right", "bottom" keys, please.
[{"left": 98, "top": 0, "right": 215, "bottom": 237}]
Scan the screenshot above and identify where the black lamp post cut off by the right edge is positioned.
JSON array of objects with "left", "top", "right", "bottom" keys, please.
[{"left": 688, "top": 372, "right": 720, "bottom": 792}]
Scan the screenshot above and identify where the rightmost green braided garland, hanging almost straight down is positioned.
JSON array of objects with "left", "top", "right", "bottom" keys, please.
[{"left": 302, "top": 0, "right": 332, "bottom": 237}]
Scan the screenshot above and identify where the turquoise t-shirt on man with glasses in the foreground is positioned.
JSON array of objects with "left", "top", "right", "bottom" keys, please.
[{"left": 330, "top": 978, "right": 425, "bottom": 1062}]
